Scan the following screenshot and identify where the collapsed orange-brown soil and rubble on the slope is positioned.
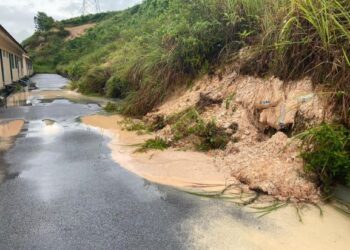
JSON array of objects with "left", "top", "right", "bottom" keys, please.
[{"left": 144, "top": 70, "right": 327, "bottom": 201}]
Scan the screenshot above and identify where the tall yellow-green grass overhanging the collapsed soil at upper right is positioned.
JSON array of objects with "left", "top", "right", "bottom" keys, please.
[{"left": 244, "top": 0, "right": 350, "bottom": 125}]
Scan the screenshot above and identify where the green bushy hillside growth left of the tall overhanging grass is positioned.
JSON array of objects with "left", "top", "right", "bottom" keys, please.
[{"left": 26, "top": 0, "right": 262, "bottom": 115}]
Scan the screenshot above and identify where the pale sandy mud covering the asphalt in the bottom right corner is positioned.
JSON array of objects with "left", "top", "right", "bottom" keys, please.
[{"left": 186, "top": 203, "right": 350, "bottom": 250}]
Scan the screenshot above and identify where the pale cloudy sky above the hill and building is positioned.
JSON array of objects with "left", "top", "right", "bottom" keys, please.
[{"left": 0, "top": 0, "right": 142, "bottom": 42}]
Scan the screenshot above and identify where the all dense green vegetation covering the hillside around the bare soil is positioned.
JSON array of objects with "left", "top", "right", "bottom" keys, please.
[{"left": 24, "top": 0, "right": 350, "bottom": 192}]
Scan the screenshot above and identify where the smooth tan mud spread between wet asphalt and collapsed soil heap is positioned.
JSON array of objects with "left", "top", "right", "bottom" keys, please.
[{"left": 82, "top": 115, "right": 230, "bottom": 189}]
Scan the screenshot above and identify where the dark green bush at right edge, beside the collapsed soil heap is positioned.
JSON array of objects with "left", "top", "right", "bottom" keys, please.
[{"left": 298, "top": 124, "right": 350, "bottom": 194}]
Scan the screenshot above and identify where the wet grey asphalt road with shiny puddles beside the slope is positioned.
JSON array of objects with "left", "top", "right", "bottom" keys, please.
[{"left": 0, "top": 76, "right": 260, "bottom": 250}]
